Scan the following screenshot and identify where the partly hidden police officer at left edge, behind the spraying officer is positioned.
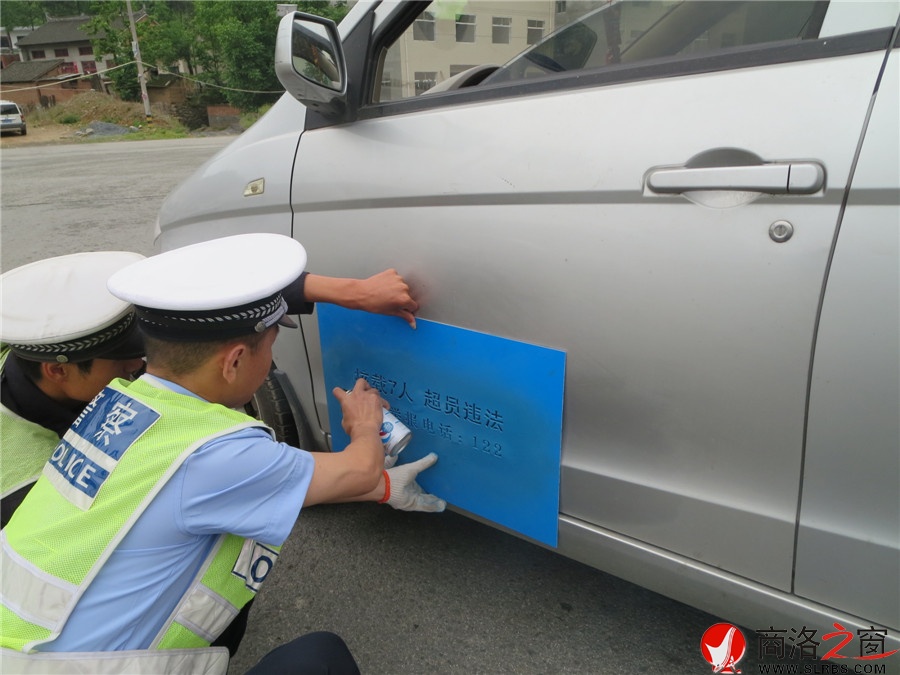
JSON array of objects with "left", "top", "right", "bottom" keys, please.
[{"left": 0, "top": 251, "right": 144, "bottom": 527}]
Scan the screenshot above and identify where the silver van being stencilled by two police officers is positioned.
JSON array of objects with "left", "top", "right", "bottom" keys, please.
[{"left": 157, "top": 0, "right": 900, "bottom": 646}]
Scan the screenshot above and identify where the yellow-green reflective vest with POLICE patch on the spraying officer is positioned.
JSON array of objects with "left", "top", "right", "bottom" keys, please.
[{"left": 0, "top": 378, "right": 278, "bottom": 672}]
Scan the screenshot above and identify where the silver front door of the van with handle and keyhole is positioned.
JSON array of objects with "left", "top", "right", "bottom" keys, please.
[{"left": 291, "top": 2, "right": 896, "bottom": 590}]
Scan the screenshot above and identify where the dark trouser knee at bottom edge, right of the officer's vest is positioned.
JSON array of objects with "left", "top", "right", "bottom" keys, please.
[{"left": 246, "top": 631, "right": 359, "bottom": 675}]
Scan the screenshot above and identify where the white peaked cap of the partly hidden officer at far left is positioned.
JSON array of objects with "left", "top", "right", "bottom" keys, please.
[{"left": 0, "top": 251, "right": 144, "bottom": 363}]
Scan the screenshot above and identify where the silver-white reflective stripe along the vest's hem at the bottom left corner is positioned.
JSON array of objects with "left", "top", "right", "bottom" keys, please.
[{"left": 0, "top": 647, "right": 228, "bottom": 675}]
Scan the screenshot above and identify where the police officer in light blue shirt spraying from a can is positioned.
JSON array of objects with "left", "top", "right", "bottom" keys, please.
[{"left": 0, "top": 234, "right": 445, "bottom": 672}]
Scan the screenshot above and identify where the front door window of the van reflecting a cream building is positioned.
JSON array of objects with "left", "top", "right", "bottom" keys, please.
[{"left": 372, "top": 0, "right": 828, "bottom": 103}]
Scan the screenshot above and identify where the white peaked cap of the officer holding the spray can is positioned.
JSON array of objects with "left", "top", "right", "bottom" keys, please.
[{"left": 108, "top": 233, "right": 306, "bottom": 341}]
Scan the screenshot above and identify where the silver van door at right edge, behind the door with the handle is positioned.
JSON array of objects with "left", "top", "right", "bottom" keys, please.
[{"left": 795, "top": 49, "right": 900, "bottom": 632}]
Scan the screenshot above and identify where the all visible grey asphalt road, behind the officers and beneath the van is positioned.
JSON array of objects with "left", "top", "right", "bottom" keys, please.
[{"left": 0, "top": 137, "right": 759, "bottom": 675}]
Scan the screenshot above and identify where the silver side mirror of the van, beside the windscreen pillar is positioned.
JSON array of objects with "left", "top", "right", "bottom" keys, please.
[{"left": 275, "top": 12, "right": 347, "bottom": 119}]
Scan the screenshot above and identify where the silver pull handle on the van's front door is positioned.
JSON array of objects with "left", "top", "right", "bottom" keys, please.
[{"left": 647, "top": 162, "right": 825, "bottom": 195}]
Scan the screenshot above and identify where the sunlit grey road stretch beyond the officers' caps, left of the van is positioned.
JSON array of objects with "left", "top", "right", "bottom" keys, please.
[{"left": 0, "top": 136, "right": 233, "bottom": 270}]
